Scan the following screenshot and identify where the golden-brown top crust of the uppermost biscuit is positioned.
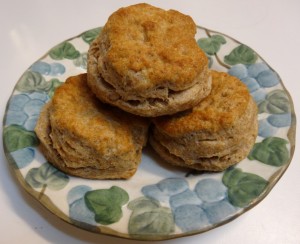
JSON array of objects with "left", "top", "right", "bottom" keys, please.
[{"left": 97, "top": 4, "right": 208, "bottom": 91}]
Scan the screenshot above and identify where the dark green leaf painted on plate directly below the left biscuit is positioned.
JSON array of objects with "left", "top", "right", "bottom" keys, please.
[{"left": 84, "top": 186, "right": 129, "bottom": 225}]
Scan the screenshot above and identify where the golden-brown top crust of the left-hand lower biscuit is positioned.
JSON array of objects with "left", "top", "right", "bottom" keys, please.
[{"left": 50, "top": 74, "right": 146, "bottom": 155}]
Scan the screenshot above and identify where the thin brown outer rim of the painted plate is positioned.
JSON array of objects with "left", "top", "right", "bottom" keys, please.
[{"left": 2, "top": 25, "right": 297, "bottom": 241}]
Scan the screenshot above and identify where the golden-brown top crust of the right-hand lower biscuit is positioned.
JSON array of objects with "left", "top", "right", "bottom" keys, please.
[{"left": 154, "top": 71, "right": 252, "bottom": 137}]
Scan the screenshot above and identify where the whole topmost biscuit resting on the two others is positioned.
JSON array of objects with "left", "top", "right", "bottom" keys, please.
[{"left": 88, "top": 4, "right": 211, "bottom": 117}]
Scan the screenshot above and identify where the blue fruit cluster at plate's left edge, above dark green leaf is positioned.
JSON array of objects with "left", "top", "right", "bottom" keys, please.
[{"left": 5, "top": 92, "right": 49, "bottom": 131}]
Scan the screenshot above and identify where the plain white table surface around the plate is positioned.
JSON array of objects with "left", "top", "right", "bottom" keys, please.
[{"left": 0, "top": 0, "right": 300, "bottom": 244}]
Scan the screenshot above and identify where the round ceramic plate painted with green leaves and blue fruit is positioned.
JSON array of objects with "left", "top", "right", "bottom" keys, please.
[{"left": 3, "top": 27, "right": 296, "bottom": 240}]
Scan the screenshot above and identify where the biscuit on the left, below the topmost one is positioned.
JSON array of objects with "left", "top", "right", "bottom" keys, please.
[{"left": 35, "top": 74, "right": 149, "bottom": 179}]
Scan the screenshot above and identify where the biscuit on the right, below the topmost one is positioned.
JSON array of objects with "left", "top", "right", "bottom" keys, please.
[{"left": 150, "top": 71, "right": 258, "bottom": 171}]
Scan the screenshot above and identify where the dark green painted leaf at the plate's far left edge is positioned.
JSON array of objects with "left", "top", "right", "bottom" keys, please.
[{"left": 3, "top": 125, "right": 39, "bottom": 152}]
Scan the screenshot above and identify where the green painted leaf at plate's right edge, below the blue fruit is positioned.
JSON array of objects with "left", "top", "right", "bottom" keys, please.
[{"left": 248, "top": 137, "right": 290, "bottom": 167}]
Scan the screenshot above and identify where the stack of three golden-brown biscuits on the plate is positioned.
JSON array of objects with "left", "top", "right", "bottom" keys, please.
[{"left": 35, "top": 4, "right": 257, "bottom": 179}]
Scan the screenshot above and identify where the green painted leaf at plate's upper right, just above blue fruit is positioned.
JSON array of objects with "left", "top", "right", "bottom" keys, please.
[{"left": 224, "top": 44, "right": 258, "bottom": 65}]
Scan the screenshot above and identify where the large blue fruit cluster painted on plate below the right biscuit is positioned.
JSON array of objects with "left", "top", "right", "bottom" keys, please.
[{"left": 142, "top": 178, "right": 237, "bottom": 232}]
